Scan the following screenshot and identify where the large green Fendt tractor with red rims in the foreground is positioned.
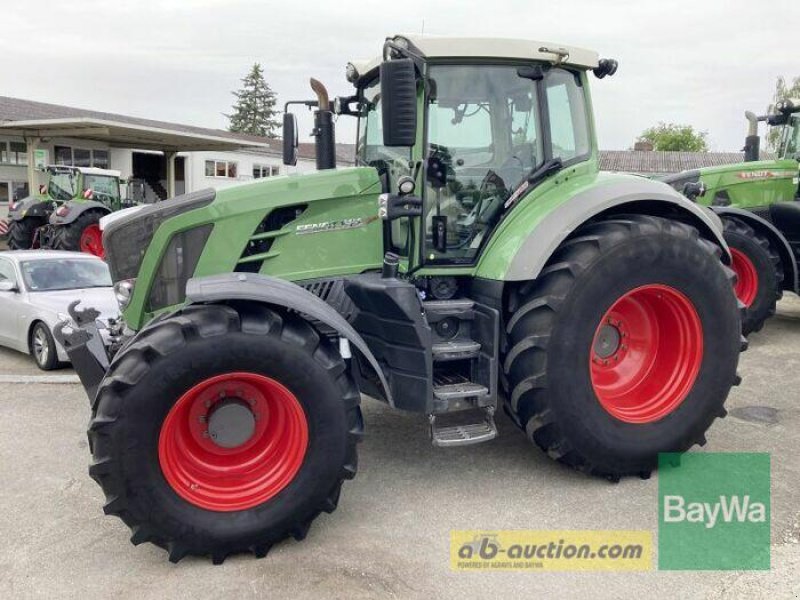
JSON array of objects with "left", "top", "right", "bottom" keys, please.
[{"left": 56, "top": 36, "right": 743, "bottom": 563}]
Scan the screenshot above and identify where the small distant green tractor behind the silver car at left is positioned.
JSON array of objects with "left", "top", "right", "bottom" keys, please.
[{"left": 8, "top": 166, "right": 128, "bottom": 258}]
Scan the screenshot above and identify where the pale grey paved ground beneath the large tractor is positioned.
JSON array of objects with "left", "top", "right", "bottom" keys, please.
[{"left": 0, "top": 298, "right": 800, "bottom": 600}]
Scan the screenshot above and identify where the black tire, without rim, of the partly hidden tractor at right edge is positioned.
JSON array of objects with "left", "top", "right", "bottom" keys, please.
[{"left": 722, "top": 216, "right": 784, "bottom": 335}]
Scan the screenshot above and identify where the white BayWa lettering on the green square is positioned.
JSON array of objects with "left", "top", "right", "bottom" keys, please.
[{"left": 663, "top": 496, "right": 767, "bottom": 529}]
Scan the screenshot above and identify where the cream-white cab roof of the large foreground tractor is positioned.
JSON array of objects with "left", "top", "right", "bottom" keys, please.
[{"left": 353, "top": 35, "right": 600, "bottom": 80}]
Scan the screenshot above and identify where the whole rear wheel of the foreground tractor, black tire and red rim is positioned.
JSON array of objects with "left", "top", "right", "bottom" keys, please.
[{"left": 503, "top": 216, "right": 741, "bottom": 479}]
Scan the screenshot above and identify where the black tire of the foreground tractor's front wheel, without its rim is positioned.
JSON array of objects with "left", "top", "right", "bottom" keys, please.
[{"left": 89, "top": 304, "right": 363, "bottom": 564}]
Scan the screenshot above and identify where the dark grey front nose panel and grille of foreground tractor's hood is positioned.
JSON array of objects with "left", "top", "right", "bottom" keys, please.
[{"left": 103, "top": 190, "right": 216, "bottom": 281}]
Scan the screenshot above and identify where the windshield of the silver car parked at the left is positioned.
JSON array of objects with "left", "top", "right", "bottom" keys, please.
[{"left": 20, "top": 258, "right": 111, "bottom": 292}]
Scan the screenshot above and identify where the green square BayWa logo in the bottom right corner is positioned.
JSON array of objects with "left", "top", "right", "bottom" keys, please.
[{"left": 658, "top": 452, "right": 770, "bottom": 570}]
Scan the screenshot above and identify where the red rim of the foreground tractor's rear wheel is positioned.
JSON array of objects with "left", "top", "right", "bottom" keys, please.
[{"left": 590, "top": 284, "right": 703, "bottom": 423}]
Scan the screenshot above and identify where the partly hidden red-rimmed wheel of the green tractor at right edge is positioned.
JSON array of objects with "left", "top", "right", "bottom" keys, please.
[{"left": 722, "top": 217, "right": 784, "bottom": 335}]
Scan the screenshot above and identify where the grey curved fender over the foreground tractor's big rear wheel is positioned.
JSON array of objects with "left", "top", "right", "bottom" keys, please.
[{"left": 488, "top": 173, "right": 730, "bottom": 281}]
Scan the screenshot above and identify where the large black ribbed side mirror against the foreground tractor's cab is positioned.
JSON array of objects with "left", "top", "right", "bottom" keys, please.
[{"left": 380, "top": 58, "right": 417, "bottom": 146}]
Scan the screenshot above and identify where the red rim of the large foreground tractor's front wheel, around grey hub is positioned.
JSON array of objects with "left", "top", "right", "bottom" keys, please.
[{"left": 158, "top": 373, "right": 308, "bottom": 512}]
